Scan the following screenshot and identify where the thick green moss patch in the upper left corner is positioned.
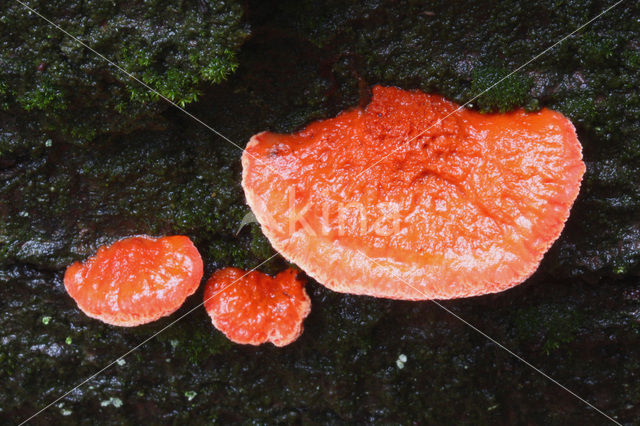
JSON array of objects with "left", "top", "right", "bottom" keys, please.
[{"left": 0, "top": 0, "right": 248, "bottom": 142}]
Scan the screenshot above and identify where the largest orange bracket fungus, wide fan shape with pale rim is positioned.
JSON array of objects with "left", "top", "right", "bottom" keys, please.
[{"left": 242, "top": 86, "right": 585, "bottom": 300}]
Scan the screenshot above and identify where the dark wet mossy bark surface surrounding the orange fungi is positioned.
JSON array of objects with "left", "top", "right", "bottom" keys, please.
[{"left": 0, "top": 1, "right": 640, "bottom": 424}]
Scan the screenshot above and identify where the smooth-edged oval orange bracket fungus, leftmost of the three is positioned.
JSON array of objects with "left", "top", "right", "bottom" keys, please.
[{"left": 64, "top": 235, "right": 203, "bottom": 327}]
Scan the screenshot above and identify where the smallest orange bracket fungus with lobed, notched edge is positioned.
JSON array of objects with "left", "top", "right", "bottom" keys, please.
[{"left": 204, "top": 268, "right": 311, "bottom": 346}]
